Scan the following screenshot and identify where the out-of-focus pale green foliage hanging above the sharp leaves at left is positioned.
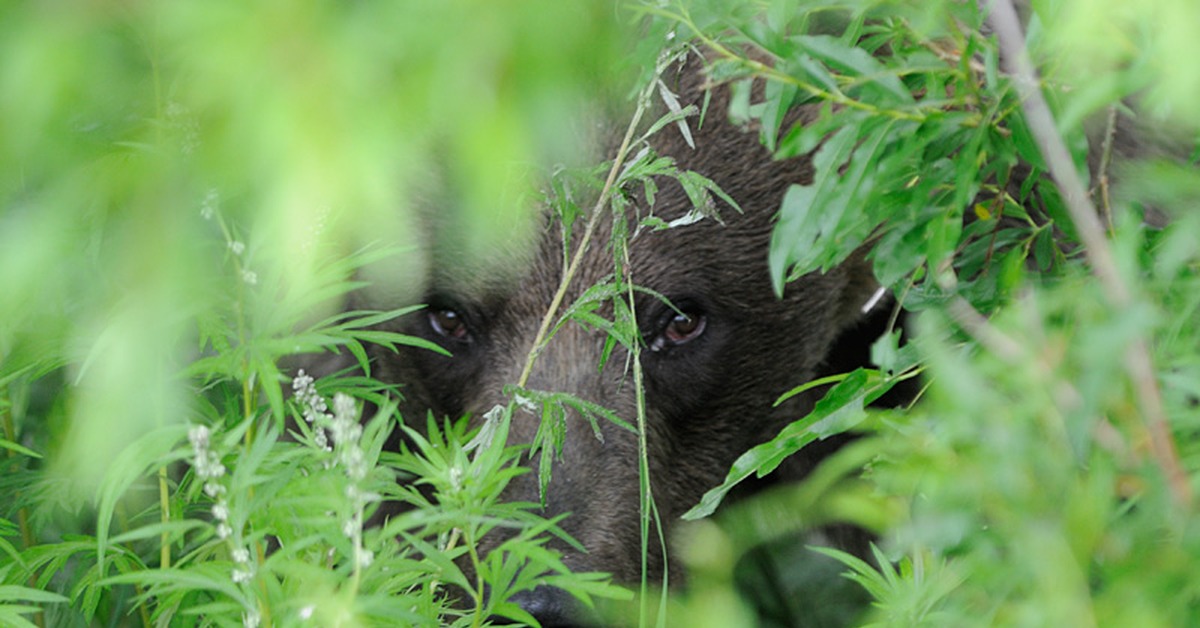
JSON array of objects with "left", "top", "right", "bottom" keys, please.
[{"left": 0, "top": 1, "right": 619, "bottom": 492}]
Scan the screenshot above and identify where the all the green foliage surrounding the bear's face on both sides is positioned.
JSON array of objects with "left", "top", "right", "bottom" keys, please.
[{"left": 0, "top": 0, "right": 1200, "bottom": 626}]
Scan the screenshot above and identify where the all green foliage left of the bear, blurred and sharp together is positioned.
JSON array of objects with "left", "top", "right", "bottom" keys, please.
[{"left": 0, "top": 0, "right": 634, "bottom": 626}]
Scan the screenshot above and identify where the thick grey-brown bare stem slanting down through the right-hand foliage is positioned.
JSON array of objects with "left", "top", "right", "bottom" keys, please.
[{"left": 989, "top": 0, "right": 1192, "bottom": 507}]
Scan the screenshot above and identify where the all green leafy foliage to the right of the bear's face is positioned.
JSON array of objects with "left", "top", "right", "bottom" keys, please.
[{"left": 656, "top": 0, "right": 1200, "bottom": 626}]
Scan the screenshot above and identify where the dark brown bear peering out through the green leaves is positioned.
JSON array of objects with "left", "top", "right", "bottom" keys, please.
[{"left": 364, "top": 55, "right": 877, "bottom": 626}]
